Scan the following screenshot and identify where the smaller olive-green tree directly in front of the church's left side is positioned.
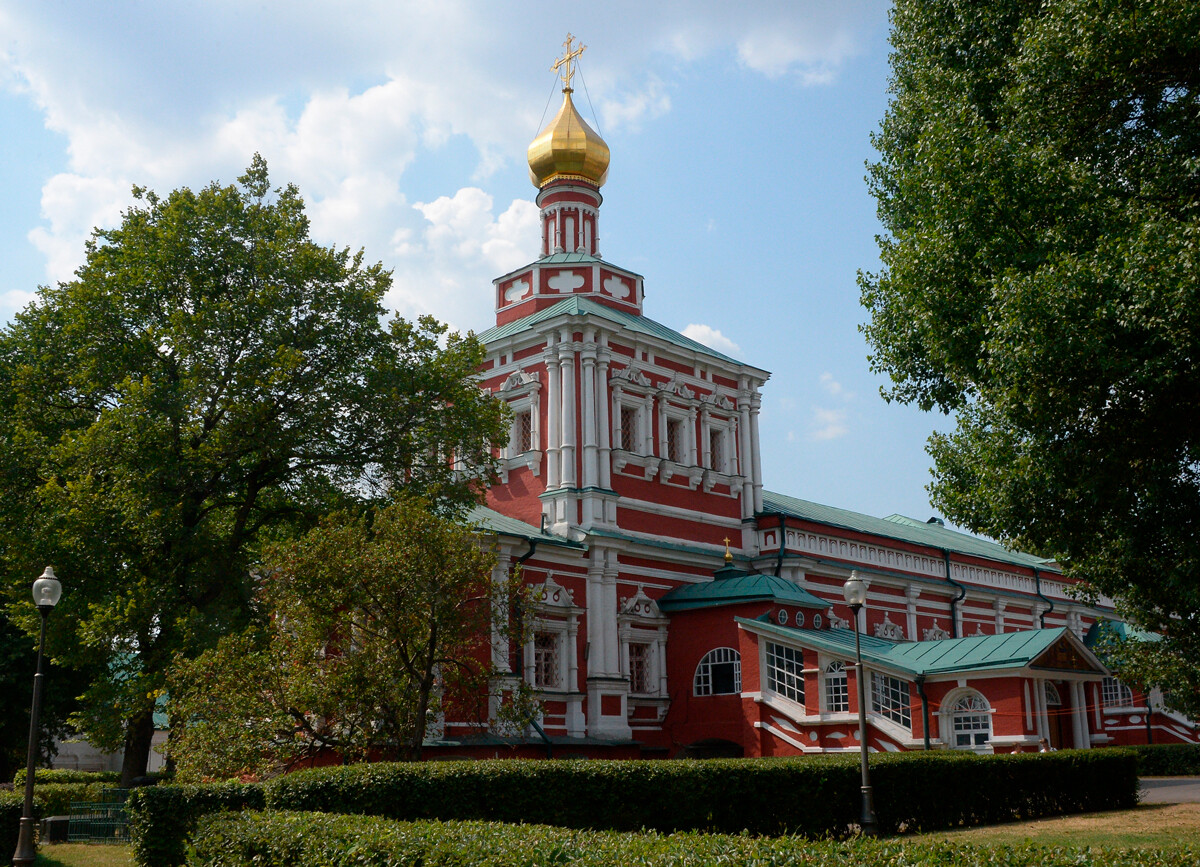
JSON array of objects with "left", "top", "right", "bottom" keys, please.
[{"left": 170, "top": 500, "right": 535, "bottom": 779}]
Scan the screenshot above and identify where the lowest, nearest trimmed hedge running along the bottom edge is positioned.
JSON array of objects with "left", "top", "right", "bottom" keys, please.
[{"left": 187, "top": 813, "right": 1200, "bottom": 867}]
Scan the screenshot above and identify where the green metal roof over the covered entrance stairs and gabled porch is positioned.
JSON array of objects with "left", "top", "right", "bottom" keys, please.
[{"left": 737, "top": 617, "right": 1103, "bottom": 676}]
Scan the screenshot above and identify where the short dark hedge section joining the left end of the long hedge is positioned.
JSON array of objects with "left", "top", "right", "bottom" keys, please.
[{"left": 127, "top": 783, "right": 263, "bottom": 867}]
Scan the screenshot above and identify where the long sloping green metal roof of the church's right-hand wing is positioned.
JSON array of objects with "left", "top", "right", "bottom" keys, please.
[{"left": 762, "top": 491, "right": 1061, "bottom": 574}]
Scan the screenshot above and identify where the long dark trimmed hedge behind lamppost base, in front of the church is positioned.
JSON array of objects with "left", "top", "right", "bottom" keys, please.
[{"left": 266, "top": 749, "right": 1138, "bottom": 837}]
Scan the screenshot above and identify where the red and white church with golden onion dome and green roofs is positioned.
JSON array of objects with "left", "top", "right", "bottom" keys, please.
[{"left": 431, "top": 40, "right": 1200, "bottom": 757}]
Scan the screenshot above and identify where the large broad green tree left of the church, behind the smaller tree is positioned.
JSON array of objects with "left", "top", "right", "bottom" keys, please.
[{"left": 0, "top": 156, "right": 505, "bottom": 782}]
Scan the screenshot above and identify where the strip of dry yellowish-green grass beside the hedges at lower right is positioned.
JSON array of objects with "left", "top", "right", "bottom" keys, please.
[{"left": 913, "top": 803, "right": 1200, "bottom": 849}]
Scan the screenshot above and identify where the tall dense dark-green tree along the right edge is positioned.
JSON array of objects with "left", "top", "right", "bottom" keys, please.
[{"left": 860, "top": 0, "right": 1200, "bottom": 713}]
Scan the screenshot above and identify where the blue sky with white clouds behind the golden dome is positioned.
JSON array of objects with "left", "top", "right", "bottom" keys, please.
[{"left": 0, "top": 0, "right": 948, "bottom": 519}]
